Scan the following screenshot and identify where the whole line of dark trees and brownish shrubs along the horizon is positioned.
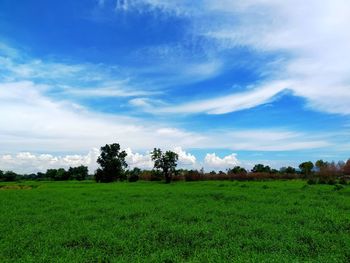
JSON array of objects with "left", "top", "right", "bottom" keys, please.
[{"left": 0, "top": 143, "right": 350, "bottom": 184}]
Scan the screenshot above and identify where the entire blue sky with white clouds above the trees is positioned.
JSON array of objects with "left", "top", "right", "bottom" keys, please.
[{"left": 0, "top": 0, "right": 350, "bottom": 173}]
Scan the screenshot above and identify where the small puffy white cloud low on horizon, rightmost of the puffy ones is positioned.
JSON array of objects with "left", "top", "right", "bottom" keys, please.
[{"left": 204, "top": 153, "right": 240, "bottom": 170}]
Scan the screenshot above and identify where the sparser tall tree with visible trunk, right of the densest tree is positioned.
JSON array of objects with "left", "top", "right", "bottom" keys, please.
[{"left": 151, "top": 148, "right": 179, "bottom": 183}]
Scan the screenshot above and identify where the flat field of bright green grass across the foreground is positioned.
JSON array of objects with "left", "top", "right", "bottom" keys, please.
[{"left": 0, "top": 181, "right": 350, "bottom": 263}]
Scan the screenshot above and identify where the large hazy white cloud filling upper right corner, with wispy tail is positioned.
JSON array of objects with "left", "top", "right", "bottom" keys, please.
[{"left": 116, "top": 0, "right": 350, "bottom": 114}]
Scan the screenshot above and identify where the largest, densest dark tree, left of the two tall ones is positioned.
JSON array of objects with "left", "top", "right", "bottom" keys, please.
[{"left": 95, "top": 143, "right": 128, "bottom": 183}]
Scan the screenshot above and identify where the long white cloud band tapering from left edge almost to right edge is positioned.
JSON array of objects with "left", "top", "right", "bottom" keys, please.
[{"left": 0, "top": 82, "right": 332, "bottom": 153}]
